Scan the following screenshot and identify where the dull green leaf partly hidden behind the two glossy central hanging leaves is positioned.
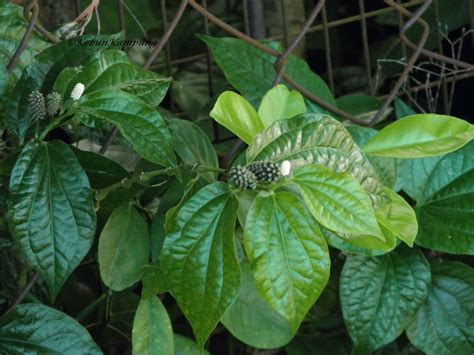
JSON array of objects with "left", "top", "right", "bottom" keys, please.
[{"left": 221, "top": 262, "right": 293, "bottom": 349}]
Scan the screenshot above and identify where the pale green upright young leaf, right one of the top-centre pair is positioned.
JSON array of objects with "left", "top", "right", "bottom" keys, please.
[{"left": 258, "top": 84, "right": 306, "bottom": 128}]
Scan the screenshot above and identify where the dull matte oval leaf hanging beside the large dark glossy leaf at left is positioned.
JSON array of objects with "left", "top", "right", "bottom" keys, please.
[{"left": 99, "top": 203, "right": 150, "bottom": 291}]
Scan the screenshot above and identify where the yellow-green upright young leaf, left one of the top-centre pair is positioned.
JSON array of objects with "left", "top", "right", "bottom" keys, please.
[{"left": 209, "top": 91, "right": 264, "bottom": 144}]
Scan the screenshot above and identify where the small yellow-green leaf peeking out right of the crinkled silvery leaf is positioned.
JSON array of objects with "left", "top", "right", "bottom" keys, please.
[{"left": 375, "top": 188, "right": 418, "bottom": 247}]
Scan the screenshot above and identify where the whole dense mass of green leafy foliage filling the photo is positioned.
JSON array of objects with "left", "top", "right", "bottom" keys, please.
[{"left": 0, "top": 2, "right": 474, "bottom": 355}]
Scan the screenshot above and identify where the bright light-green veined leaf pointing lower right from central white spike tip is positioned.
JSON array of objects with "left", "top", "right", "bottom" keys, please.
[{"left": 291, "top": 164, "right": 383, "bottom": 239}]
